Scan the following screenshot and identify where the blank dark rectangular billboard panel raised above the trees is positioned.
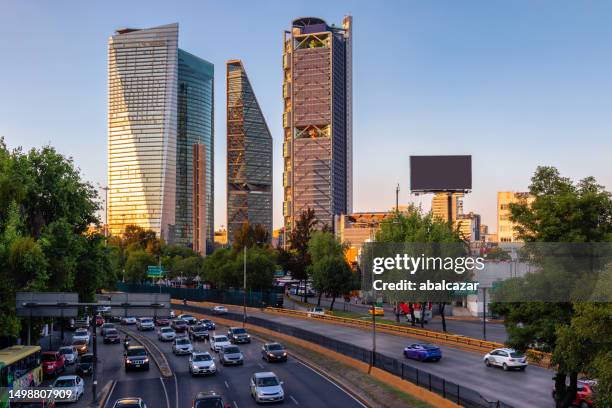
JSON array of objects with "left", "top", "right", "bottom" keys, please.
[{"left": 410, "top": 156, "right": 472, "bottom": 192}]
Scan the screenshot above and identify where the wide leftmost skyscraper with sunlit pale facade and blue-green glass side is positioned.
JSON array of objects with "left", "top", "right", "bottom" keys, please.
[{"left": 108, "top": 24, "right": 214, "bottom": 253}]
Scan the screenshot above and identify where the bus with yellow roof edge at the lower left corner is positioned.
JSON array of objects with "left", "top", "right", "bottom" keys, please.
[{"left": 0, "top": 346, "right": 43, "bottom": 407}]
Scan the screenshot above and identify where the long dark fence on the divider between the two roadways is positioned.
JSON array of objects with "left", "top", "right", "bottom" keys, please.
[{"left": 181, "top": 306, "right": 512, "bottom": 408}]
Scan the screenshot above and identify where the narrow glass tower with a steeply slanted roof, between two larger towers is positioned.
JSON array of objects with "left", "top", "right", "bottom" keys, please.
[{"left": 227, "top": 60, "right": 272, "bottom": 242}]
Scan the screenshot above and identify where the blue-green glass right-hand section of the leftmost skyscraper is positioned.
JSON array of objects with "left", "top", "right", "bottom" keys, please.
[{"left": 175, "top": 49, "right": 215, "bottom": 254}]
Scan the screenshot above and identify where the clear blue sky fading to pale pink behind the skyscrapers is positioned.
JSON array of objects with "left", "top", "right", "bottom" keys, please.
[{"left": 0, "top": 0, "right": 612, "bottom": 230}]
